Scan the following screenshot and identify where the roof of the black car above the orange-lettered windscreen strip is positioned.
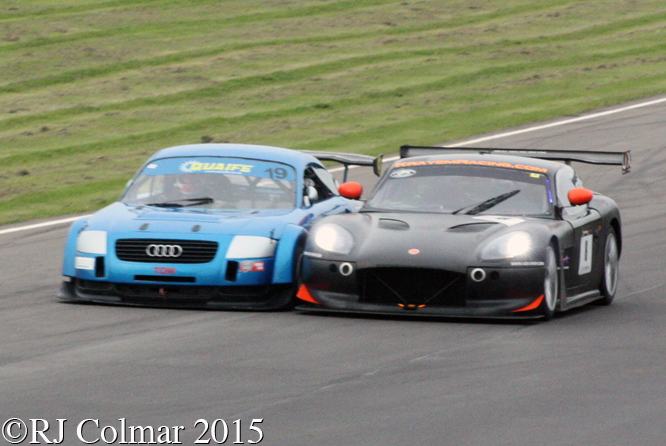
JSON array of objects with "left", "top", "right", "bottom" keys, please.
[{"left": 393, "top": 153, "right": 567, "bottom": 176}]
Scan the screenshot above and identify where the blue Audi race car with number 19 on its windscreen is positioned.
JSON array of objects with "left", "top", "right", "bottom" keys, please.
[{"left": 58, "top": 144, "right": 381, "bottom": 310}]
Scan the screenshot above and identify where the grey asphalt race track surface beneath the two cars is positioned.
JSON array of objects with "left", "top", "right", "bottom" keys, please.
[{"left": 0, "top": 98, "right": 666, "bottom": 446}]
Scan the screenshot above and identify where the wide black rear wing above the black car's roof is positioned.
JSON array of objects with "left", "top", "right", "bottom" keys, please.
[{"left": 400, "top": 145, "right": 631, "bottom": 174}]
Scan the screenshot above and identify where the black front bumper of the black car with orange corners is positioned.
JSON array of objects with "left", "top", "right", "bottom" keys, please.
[{"left": 299, "top": 258, "right": 545, "bottom": 318}]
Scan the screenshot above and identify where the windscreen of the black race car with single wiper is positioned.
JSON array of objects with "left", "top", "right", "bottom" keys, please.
[{"left": 363, "top": 162, "right": 553, "bottom": 216}]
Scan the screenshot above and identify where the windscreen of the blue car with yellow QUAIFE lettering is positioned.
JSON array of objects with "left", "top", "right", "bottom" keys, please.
[{"left": 120, "top": 157, "right": 296, "bottom": 209}]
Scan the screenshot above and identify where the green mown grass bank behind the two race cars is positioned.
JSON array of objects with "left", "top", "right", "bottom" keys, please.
[{"left": 0, "top": 0, "right": 666, "bottom": 224}]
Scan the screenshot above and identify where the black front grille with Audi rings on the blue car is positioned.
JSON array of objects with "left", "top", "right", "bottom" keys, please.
[{"left": 116, "top": 238, "right": 218, "bottom": 263}]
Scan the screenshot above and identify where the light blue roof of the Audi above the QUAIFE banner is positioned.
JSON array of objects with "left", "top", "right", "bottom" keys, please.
[{"left": 148, "top": 144, "right": 321, "bottom": 169}]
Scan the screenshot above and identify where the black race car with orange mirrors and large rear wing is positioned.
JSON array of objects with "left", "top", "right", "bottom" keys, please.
[{"left": 298, "top": 146, "right": 630, "bottom": 319}]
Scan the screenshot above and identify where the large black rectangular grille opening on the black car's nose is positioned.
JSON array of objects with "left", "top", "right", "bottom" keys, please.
[{"left": 358, "top": 268, "right": 466, "bottom": 307}]
